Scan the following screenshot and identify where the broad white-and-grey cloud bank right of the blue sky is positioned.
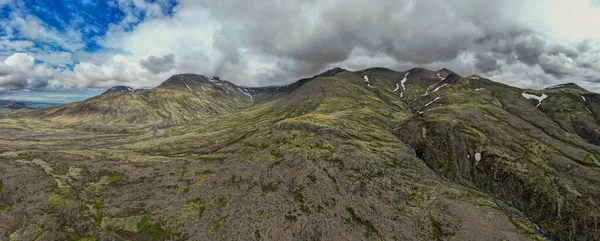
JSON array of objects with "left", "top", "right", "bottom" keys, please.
[{"left": 0, "top": 0, "right": 600, "bottom": 91}]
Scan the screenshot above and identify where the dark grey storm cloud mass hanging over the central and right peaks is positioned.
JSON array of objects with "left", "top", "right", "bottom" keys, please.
[{"left": 199, "top": 0, "right": 596, "bottom": 86}]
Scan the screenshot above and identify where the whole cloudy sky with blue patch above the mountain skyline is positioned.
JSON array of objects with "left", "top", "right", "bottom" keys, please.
[{"left": 0, "top": 0, "right": 600, "bottom": 92}]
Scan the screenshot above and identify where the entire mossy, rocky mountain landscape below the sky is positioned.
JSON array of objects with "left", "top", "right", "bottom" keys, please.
[{"left": 0, "top": 68, "right": 600, "bottom": 240}]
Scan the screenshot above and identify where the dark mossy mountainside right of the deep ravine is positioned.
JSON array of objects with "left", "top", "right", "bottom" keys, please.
[{"left": 398, "top": 76, "right": 600, "bottom": 240}]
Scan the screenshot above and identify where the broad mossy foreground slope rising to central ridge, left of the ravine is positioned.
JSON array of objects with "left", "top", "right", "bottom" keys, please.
[{"left": 0, "top": 72, "right": 539, "bottom": 240}]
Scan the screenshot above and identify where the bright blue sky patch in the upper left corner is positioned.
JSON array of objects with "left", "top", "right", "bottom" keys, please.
[{"left": 0, "top": 0, "right": 177, "bottom": 59}]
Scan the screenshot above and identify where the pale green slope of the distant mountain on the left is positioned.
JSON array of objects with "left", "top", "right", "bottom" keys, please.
[{"left": 40, "top": 77, "right": 252, "bottom": 129}]
